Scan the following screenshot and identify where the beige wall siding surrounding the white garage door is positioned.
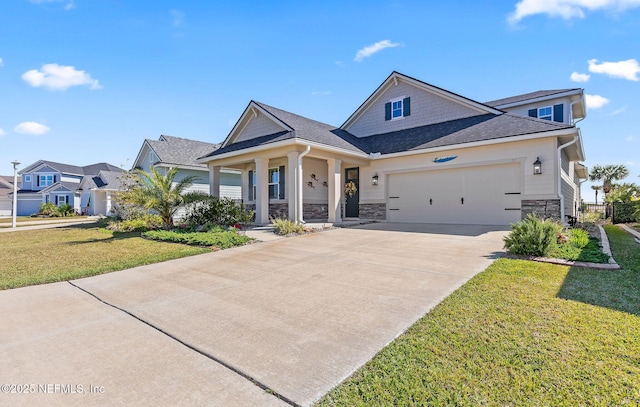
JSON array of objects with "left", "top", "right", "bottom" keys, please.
[{"left": 360, "top": 138, "right": 558, "bottom": 204}]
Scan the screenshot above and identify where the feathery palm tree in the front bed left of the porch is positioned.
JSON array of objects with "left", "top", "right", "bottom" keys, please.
[{"left": 125, "top": 167, "right": 197, "bottom": 229}]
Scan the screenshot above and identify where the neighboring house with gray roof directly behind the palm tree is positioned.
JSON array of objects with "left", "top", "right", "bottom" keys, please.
[{"left": 133, "top": 135, "right": 242, "bottom": 218}]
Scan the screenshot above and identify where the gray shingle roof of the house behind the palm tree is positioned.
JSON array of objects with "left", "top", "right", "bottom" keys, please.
[{"left": 147, "top": 135, "right": 220, "bottom": 168}]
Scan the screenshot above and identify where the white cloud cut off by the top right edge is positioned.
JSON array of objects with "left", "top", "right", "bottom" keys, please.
[{"left": 507, "top": 0, "right": 640, "bottom": 24}]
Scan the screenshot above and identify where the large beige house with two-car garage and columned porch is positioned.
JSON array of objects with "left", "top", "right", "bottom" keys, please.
[{"left": 198, "top": 72, "right": 586, "bottom": 225}]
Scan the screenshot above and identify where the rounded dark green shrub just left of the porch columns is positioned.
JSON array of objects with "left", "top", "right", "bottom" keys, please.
[{"left": 183, "top": 196, "right": 253, "bottom": 226}]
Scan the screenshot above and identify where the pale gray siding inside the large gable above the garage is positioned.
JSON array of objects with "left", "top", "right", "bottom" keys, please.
[{"left": 346, "top": 81, "right": 482, "bottom": 137}]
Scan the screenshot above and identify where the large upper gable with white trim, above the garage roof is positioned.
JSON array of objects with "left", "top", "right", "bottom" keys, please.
[{"left": 341, "top": 72, "right": 501, "bottom": 137}]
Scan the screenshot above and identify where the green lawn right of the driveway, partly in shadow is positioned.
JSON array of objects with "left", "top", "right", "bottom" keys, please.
[{"left": 318, "top": 226, "right": 640, "bottom": 406}]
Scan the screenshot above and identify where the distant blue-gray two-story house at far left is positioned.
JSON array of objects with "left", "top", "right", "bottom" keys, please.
[{"left": 17, "top": 160, "right": 124, "bottom": 216}]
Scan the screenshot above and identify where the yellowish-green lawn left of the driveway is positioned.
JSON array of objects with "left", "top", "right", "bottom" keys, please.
[{"left": 0, "top": 224, "right": 211, "bottom": 290}]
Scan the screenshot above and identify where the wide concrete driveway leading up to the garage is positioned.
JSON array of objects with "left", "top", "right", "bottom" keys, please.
[{"left": 0, "top": 223, "right": 507, "bottom": 406}]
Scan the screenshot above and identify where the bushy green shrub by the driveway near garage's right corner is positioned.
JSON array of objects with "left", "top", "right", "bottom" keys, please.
[{"left": 504, "top": 214, "right": 562, "bottom": 256}]
